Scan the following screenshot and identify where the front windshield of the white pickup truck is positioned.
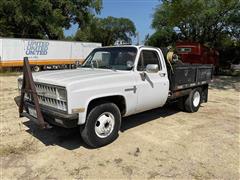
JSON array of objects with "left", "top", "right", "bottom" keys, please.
[{"left": 82, "top": 47, "right": 137, "bottom": 70}]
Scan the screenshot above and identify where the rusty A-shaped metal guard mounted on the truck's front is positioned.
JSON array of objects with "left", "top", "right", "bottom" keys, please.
[{"left": 19, "top": 57, "right": 48, "bottom": 128}]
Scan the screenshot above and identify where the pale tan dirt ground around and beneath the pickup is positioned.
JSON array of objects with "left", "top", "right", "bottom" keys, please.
[{"left": 0, "top": 76, "right": 240, "bottom": 180}]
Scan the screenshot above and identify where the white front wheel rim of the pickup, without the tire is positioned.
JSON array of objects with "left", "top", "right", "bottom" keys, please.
[{"left": 95, "top": 112, "right": 115, "bottom": 138}]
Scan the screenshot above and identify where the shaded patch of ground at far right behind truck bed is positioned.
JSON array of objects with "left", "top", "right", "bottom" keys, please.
[{"left": 210, "top": 76, "right": 240, "bottom": 91}]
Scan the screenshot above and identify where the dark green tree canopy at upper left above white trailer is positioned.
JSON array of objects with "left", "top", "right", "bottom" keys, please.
[{"left": 0, "top": 0, "right": 102, "bottom": 39}]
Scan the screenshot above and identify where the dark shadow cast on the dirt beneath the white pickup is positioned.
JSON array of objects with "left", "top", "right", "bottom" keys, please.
[{"left": 23, "top": 105, "right": 179, "bottom": 150}]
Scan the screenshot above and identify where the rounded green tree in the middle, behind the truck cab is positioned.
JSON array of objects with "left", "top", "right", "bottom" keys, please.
[{"left": 75, "top": 17, "right": 136, "bottom": 46}]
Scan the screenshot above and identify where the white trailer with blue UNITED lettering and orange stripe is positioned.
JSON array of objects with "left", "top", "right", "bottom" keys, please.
[{"left": 0, "top": 38, "right": 102, "bottom": 70}]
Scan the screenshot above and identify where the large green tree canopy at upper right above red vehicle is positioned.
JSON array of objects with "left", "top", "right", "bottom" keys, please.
[{"left": 149, "top": 0, "right": 240, "bottom": 47}]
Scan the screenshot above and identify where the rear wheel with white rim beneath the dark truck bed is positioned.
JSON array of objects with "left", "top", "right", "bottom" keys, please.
[{"left": 184, "top": 88, "right": 202, "bottom": 113}]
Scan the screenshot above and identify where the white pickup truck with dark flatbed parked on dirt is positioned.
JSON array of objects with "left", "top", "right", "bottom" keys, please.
[{"left": 15, "top": 45, "right": 213, "bottom": 147}]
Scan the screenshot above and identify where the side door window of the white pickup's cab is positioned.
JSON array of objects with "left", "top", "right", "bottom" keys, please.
[{"left": 137, "top": 50, "right": 161, "bottom": 71}]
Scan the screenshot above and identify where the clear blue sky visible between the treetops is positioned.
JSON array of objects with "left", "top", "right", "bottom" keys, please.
[{"left": 65, "top": 0, "right": 160, "bottom": 43}]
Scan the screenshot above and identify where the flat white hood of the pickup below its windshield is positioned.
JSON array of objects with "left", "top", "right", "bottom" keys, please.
[{"left": 33, "top": 68, "right": 129, "bottom": 87}]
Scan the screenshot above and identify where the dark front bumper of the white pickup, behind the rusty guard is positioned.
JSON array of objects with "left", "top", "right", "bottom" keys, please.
[{"left": 15, "top": 98, "right": 78, "bottom": 128}]
